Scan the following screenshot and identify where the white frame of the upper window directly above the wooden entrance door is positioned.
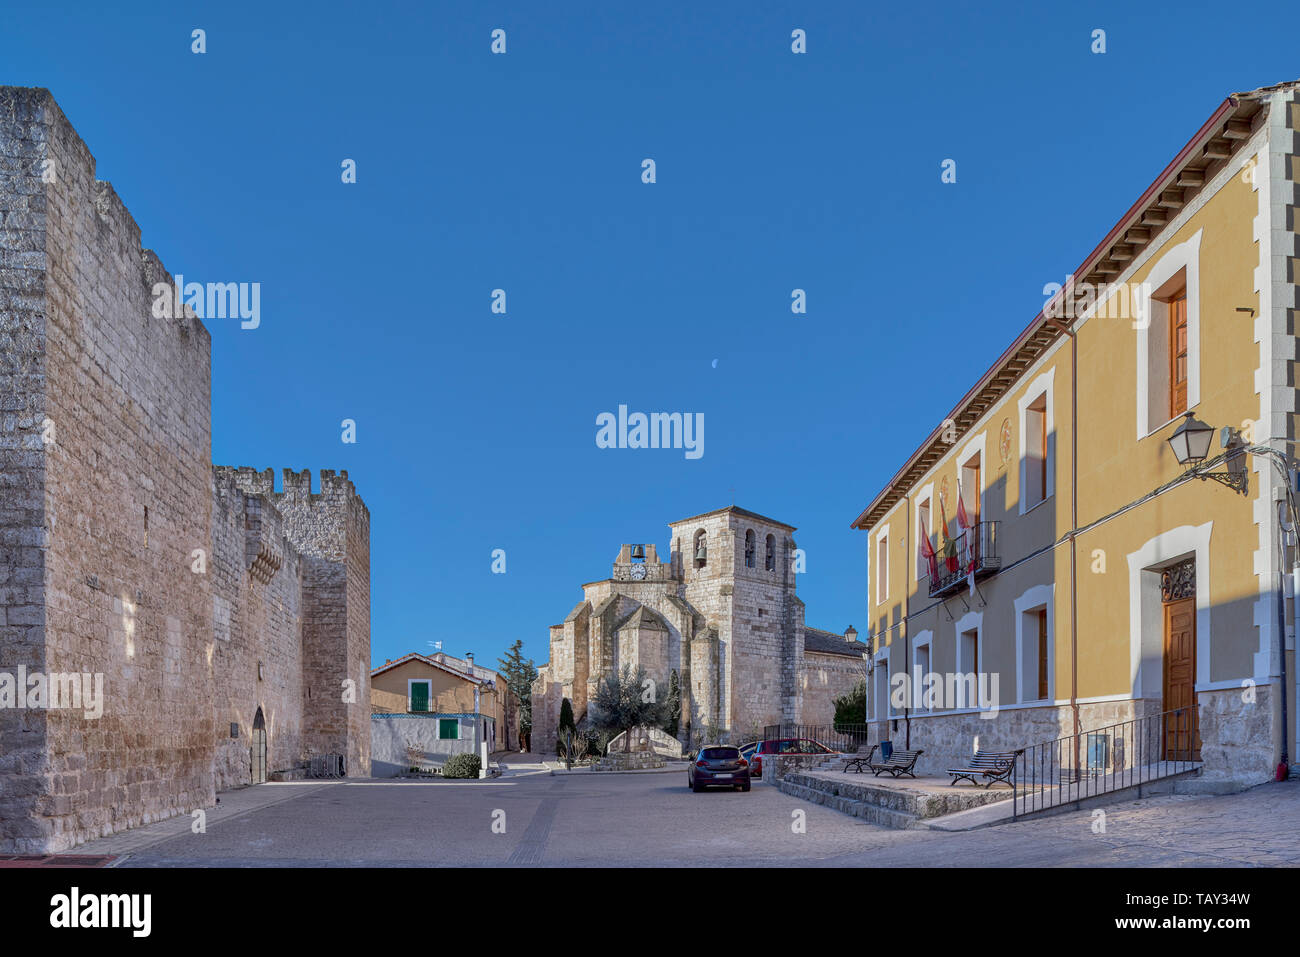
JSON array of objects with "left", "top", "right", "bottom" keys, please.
[{"left": 1134, "top": 229, "right": 1204, "bottom": 439}]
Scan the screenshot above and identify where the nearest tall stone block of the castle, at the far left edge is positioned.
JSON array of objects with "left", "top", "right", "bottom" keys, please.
[{"left": 0, "top": 87, "right": 213, "bottom": 850}]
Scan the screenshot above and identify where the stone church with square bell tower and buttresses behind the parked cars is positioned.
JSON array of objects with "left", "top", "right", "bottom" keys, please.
[{"left": 533, "top": 506, "right": 866, "bottom": 753}]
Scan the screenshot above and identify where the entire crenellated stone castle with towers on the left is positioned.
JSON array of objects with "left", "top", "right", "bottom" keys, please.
[{"left": 0, "top": 87, "right": 371, "bottom": 854}]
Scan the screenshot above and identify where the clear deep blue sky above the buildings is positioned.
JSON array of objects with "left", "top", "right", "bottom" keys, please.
[{"left": 0, "top": 0, "right": 1300, "bottom": 663}]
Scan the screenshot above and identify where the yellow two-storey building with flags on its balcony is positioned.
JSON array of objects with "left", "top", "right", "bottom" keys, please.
[{"left": 853, "top": 83, "right": 1300, "bottom": 789}]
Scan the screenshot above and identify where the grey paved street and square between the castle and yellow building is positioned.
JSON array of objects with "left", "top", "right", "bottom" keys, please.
[{"left": 68, "top": 774, "right": 1300, "bottom": 867}]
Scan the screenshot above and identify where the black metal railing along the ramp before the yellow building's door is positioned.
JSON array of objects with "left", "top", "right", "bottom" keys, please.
[{"left": 1011, "top": 707, "right": 1201, "bottom": 817}]
